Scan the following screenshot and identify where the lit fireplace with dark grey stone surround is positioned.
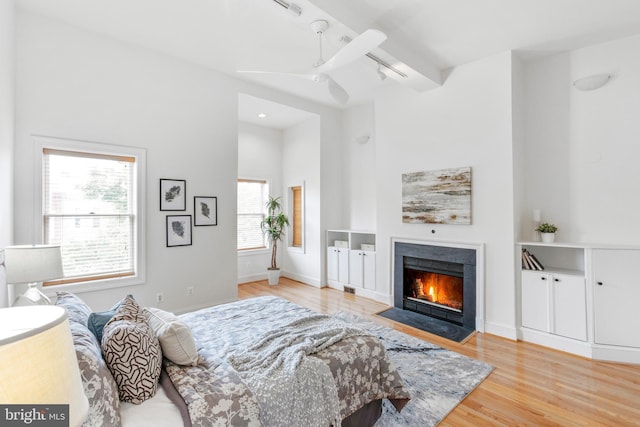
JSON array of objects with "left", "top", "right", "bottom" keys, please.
[{"left": 394, "top": 242, "right": 476, "bottom": 330}]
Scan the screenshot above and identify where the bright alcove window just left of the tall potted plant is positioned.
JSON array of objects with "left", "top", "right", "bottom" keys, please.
[{"left": 238, "top": 179, "right": 269, "bottom": 251}]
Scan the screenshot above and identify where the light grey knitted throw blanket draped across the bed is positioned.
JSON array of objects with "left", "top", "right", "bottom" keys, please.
[{"left": 229, "top": 315, "right": 368, "bottom": 427}]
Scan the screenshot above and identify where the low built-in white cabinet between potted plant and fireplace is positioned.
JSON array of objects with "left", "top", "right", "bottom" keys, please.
[{"left": 327, "top": 230, "right": 376, "bottom": 296}]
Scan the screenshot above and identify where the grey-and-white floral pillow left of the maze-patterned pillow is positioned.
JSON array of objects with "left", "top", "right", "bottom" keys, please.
[{"left": 56, "top": 292, "right": 121, "bottom": 427}]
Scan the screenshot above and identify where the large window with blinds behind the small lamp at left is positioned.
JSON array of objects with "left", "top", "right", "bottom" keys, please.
[{"left": 40, "top": 138, "right": 144, "bottom": 289}]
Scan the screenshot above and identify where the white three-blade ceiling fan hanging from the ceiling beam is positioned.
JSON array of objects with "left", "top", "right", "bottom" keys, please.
[{"left": 238, "top": 19, "right": 387, "bottom": 105}]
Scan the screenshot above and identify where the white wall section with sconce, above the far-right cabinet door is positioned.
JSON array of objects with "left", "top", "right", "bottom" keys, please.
[{"left": 569, "top": 35, "right": 640, "bottom": 244}]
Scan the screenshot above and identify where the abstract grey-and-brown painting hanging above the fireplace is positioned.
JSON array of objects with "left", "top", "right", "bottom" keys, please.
[{"left": 402, "top": 167, "right": 471, "bottom": 224}]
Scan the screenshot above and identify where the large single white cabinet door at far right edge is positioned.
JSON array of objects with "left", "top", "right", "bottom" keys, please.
[{"left": 593, "top": 249, "right": 640, "bottom": 347}]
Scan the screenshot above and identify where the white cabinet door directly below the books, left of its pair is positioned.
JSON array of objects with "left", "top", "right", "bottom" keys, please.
[{"left": 521, "top": 271, "right": 551, "bottom": 332}]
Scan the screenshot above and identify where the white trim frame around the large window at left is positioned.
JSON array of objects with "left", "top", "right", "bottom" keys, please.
[{"left": 31, "top": 135, "right": 147, "bottom": 296}]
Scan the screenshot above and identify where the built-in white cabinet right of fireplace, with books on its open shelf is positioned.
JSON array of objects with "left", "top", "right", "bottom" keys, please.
[{"left": 517, "top": 242, "right": 640, "bottom": 364}]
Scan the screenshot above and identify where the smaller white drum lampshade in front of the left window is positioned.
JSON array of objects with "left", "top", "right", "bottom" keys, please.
[{"left": 4, "top": 245, "right": 64, "bottom": 284}]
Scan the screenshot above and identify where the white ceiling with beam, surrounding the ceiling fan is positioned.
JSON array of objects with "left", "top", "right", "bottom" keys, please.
[{"left": 16, "top": 0, "right": 640, "bottom": 126}]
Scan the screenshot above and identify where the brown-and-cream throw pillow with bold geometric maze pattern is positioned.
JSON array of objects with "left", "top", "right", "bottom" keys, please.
[{"left": 102, "top": 296, "right": 162, "bottom": 404}]
